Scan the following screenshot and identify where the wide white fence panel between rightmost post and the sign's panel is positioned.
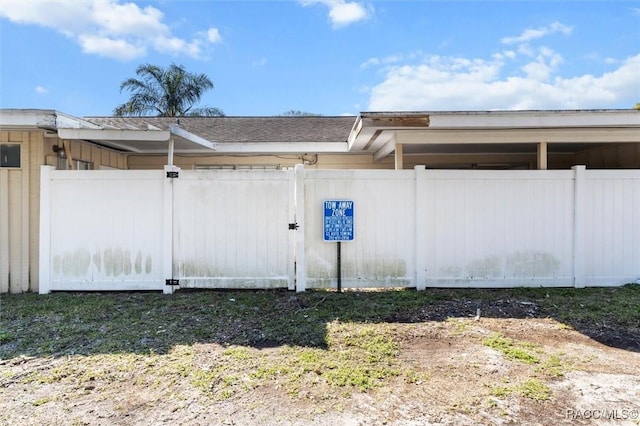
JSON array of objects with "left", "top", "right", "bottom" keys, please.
[{"left": 417, "top": 170, "right": 573, "bottom": 287}]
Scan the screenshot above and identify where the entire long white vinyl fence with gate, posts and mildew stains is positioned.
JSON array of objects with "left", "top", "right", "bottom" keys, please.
[{"left": 40, "top": 166, "right": 640, "bottom": 293}]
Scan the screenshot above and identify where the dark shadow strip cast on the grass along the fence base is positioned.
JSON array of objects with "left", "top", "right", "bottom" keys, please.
[{"left": 0, "top": 285, "right": 640, "bottom": 359}]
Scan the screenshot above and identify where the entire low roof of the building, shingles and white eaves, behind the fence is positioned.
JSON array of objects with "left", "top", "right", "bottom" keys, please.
[{"left": 0, "top": 109, "right": 640, "bottom": 161}]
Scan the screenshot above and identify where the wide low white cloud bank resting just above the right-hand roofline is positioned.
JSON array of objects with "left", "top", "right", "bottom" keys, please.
[{"left": 368, "top": 55, "right": 640, "bottom": 111}]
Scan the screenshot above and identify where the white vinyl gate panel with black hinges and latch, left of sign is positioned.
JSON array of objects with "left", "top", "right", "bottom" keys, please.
[{"left": 173, "top": 170, "right": 294, "bottom": 288}]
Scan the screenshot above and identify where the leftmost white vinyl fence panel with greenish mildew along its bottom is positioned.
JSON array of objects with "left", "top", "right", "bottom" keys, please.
[{"left": 41, "top": 168, "right": 166, "bottom": 293}]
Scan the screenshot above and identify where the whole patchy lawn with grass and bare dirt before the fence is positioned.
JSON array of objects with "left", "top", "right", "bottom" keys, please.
[{"left": 0, "top": 285, "right": 640, "bottom": 425}]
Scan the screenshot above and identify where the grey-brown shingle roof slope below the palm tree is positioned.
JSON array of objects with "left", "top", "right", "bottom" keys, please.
[{"left": 84, "top": 116, "right": 356, "bottom": 143}]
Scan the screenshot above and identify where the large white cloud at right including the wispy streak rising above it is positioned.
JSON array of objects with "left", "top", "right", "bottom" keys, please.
[{"left": 361, "top": 23, "right": 640, "bottom": 111}]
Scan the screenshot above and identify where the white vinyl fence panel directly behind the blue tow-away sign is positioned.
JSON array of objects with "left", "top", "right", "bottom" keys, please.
[{"left": 304, "top": 170, "right": 415, "bottom": 288}]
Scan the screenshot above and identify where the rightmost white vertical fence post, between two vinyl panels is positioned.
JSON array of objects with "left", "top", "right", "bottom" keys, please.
[{"left": 571, "top": 166, "right": 586, "bottom": 288}]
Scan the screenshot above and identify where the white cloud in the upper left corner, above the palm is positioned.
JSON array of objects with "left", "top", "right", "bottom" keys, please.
[{"left": 0, "top": 0, "right": 222, "bottom": 61}]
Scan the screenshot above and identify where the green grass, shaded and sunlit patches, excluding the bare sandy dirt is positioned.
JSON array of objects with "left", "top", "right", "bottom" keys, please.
[{"left": 0, "top": 285, "right": 640, "bottom": 405}]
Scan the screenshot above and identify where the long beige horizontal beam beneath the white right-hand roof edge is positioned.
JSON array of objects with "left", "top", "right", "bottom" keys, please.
[{"left": 396, "top": 128, "right": 640, "bottom": 144}]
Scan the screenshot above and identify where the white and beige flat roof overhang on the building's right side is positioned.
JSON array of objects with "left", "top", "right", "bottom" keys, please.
[{"left": 348, "top": 110, "right": 640, "bottom": 161}]
